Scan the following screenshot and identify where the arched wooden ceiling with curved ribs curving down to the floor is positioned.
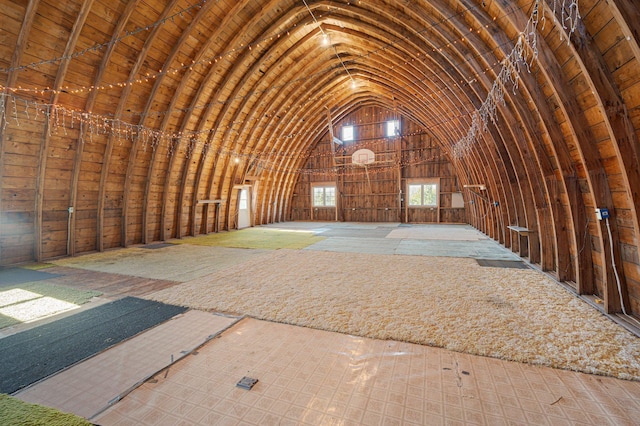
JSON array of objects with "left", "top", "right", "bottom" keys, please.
[{"left": 0, "top": 0, "right": 640, "bottom": 318}]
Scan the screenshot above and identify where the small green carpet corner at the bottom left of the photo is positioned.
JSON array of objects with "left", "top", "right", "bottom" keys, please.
[{"left": 0, "top": 394, "right": 91, "bottom": 426}]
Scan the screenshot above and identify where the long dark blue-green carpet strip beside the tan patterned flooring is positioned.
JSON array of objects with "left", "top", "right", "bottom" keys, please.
[{"left": 0, "top": 297, "right": 187, "bottom": 394}]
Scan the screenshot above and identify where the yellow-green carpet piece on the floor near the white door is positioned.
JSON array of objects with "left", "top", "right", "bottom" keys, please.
[{"left": 171, "top": 227, "right": 324, "bottom": 250}]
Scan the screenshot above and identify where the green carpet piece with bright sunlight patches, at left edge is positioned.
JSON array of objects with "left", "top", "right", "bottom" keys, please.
[{"left": 0, "top": 281, "right": 102, "bottom": 329}]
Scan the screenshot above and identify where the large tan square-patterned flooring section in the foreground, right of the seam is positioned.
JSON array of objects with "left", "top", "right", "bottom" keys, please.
[{"left": 93, "top": 319, "right": 640, "bottom": 426}]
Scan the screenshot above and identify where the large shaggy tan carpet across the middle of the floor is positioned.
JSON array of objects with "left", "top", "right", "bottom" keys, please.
[{"left": 149, "top": 250, "right": 640, "bottom": 380}]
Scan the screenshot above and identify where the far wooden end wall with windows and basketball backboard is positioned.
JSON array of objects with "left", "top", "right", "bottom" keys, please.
[{"left": 290, "top": 106, "right": 467, "bottom": 223}]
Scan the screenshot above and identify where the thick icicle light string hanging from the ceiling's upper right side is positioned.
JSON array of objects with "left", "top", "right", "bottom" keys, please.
[{"left": 453, "top": 0, "right": 580, "bottom": 158}]
